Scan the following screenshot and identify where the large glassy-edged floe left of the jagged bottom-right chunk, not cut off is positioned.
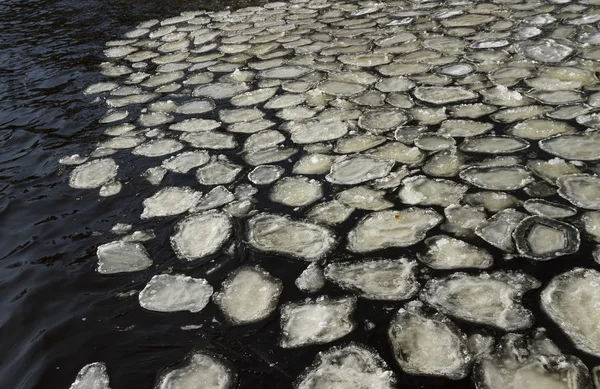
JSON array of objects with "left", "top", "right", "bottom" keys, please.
[{"left": 388, "top": 302, "right": 472, "bottom": 380}]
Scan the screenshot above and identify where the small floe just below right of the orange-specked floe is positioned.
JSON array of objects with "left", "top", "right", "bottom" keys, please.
[{"left": 418, "top": 235, "right": 494, "bottom": 270}]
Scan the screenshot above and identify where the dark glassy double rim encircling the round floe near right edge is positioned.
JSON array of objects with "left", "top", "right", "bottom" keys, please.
[{"left": 512, "top": 216, "right": 581, "bottom": 261}]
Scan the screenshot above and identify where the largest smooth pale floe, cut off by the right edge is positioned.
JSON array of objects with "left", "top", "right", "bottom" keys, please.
[{"left": 541, "top": 268, "right": 600, "bottom": 357}]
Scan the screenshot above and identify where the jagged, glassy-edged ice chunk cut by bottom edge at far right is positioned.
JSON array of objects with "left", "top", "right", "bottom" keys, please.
[{"left": 473, "top": 333, "right": 591, "bottom": 389}]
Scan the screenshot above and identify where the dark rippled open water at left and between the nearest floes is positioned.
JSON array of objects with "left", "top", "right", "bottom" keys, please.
[{"left": 0, "top": 0, "right": 597, "bottom": 389}]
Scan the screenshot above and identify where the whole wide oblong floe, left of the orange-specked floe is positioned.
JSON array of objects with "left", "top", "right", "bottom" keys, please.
[{"left": 248, "top": 213, "right": 335, "bottom": 261}]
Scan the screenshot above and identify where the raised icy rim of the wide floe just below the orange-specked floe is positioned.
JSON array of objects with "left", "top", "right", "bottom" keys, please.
[{"left": 323, "top": 257, "right": 421, "bottom": 301}]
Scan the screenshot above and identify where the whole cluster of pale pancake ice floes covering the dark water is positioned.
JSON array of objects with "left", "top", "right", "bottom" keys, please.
[{"left": 67, "top": 0, "right": 600, "bottom": 389}]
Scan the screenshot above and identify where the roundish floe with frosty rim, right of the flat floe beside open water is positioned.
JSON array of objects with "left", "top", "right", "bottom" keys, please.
[{"left": 214, "top": 267, "right": 283, "bottom": 325}]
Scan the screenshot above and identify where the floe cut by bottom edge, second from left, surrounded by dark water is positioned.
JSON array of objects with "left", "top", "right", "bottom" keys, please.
[{"left": 157, "top": 352, "right": 235, "bottom": 389}]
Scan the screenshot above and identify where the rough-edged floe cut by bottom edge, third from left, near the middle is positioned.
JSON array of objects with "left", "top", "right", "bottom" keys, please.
[{"left": 296, "top": 343, "right": 396, "bottom": 389}]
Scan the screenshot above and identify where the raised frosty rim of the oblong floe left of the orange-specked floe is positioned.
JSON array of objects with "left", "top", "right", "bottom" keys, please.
[{"left": 247, "top": 212, "right": 337, "bottom": 262}]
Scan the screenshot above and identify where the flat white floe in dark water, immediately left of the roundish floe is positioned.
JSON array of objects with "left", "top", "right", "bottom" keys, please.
[{"left": 139, "top": 274, "right": 213, "bottom": 312}]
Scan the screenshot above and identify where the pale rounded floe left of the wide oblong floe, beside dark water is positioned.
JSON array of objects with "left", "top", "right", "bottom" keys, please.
[{"left": 171, "top": 211, "right": 232, "bottom": 261}]
